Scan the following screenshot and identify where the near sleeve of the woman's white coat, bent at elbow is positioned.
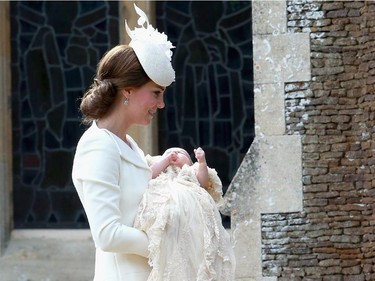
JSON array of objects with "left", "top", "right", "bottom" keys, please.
[{"left": 73, "top": 133, "right": 149, "bottom": 257}]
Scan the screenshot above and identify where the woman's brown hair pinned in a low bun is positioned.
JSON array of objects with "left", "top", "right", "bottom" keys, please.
[{"left": 80, "top": 45, "right": 151, "bottom": 124}]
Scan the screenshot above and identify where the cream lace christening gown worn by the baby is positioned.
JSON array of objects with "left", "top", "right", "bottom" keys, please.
[{"left": 135, "top": 160, "right": 235, "bottom": 281}]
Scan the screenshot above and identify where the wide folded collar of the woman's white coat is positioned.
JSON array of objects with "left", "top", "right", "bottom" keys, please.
[{"left": 92, "top": 121, "right": 150, "bottom": 170}]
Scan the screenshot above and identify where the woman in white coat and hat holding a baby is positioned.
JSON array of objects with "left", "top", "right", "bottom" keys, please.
[{"left": 72, "top": 4, "right": 174, "bottom": 281}]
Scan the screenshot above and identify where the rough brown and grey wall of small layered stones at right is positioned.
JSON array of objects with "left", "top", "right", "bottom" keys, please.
[{"left": 261, "top": 0, "right": 375, "bottom": 281}]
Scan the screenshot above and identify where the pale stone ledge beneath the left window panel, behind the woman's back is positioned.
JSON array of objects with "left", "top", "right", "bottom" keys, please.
[{"left": 0, "top": 230, "right": 95, "bottom": 281}]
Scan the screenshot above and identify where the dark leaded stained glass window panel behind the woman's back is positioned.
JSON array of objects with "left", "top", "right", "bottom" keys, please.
[{"left": 10, "top": 1, "right": 119, "bottom": 228}]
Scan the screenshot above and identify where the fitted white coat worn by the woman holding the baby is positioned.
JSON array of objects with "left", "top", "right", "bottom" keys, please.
[{"left": 72, "top": 122, "right": 152, "bottom": 281}]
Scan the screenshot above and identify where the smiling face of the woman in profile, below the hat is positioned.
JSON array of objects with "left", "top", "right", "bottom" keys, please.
[{"left": 127, "top": 81, "right": 165, "bottom": 125}]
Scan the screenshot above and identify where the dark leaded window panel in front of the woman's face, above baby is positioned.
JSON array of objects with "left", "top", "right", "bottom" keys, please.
[{"left": 156, "top": 1, "right": 254, "bottom": 210}]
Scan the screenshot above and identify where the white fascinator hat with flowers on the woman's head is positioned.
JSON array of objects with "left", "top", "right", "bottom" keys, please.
[{"left": 125, "top": 4, "right": 175, "bottom": 87}]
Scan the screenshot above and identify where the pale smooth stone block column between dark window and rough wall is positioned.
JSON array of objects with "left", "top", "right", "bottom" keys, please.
[{"left": 224, "top": 0, "right": 311, "bottom": 281}]
